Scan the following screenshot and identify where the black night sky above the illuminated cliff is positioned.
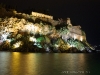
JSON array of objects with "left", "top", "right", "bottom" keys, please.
[{"left": 0, "top": 0, "right": 100, "bottom": 44}]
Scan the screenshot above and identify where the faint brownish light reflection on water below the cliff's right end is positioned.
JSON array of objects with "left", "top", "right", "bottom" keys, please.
[{"left": 53, "top": 54, "right": 87, "bottom": 75}]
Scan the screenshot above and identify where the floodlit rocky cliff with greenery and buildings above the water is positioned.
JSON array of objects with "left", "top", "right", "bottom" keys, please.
[{"left": 0, "top": 6, "right": 94, "bottom": 52}]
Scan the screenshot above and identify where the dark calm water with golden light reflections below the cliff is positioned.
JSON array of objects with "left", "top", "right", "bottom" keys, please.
[{"left": 0, "top": 52, "right": 100, "bottom": 75}]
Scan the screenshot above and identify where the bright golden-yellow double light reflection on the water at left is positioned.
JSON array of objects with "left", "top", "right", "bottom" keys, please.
[{"left": 10, "top": 52, "right": 38, "bottom": 75}]
